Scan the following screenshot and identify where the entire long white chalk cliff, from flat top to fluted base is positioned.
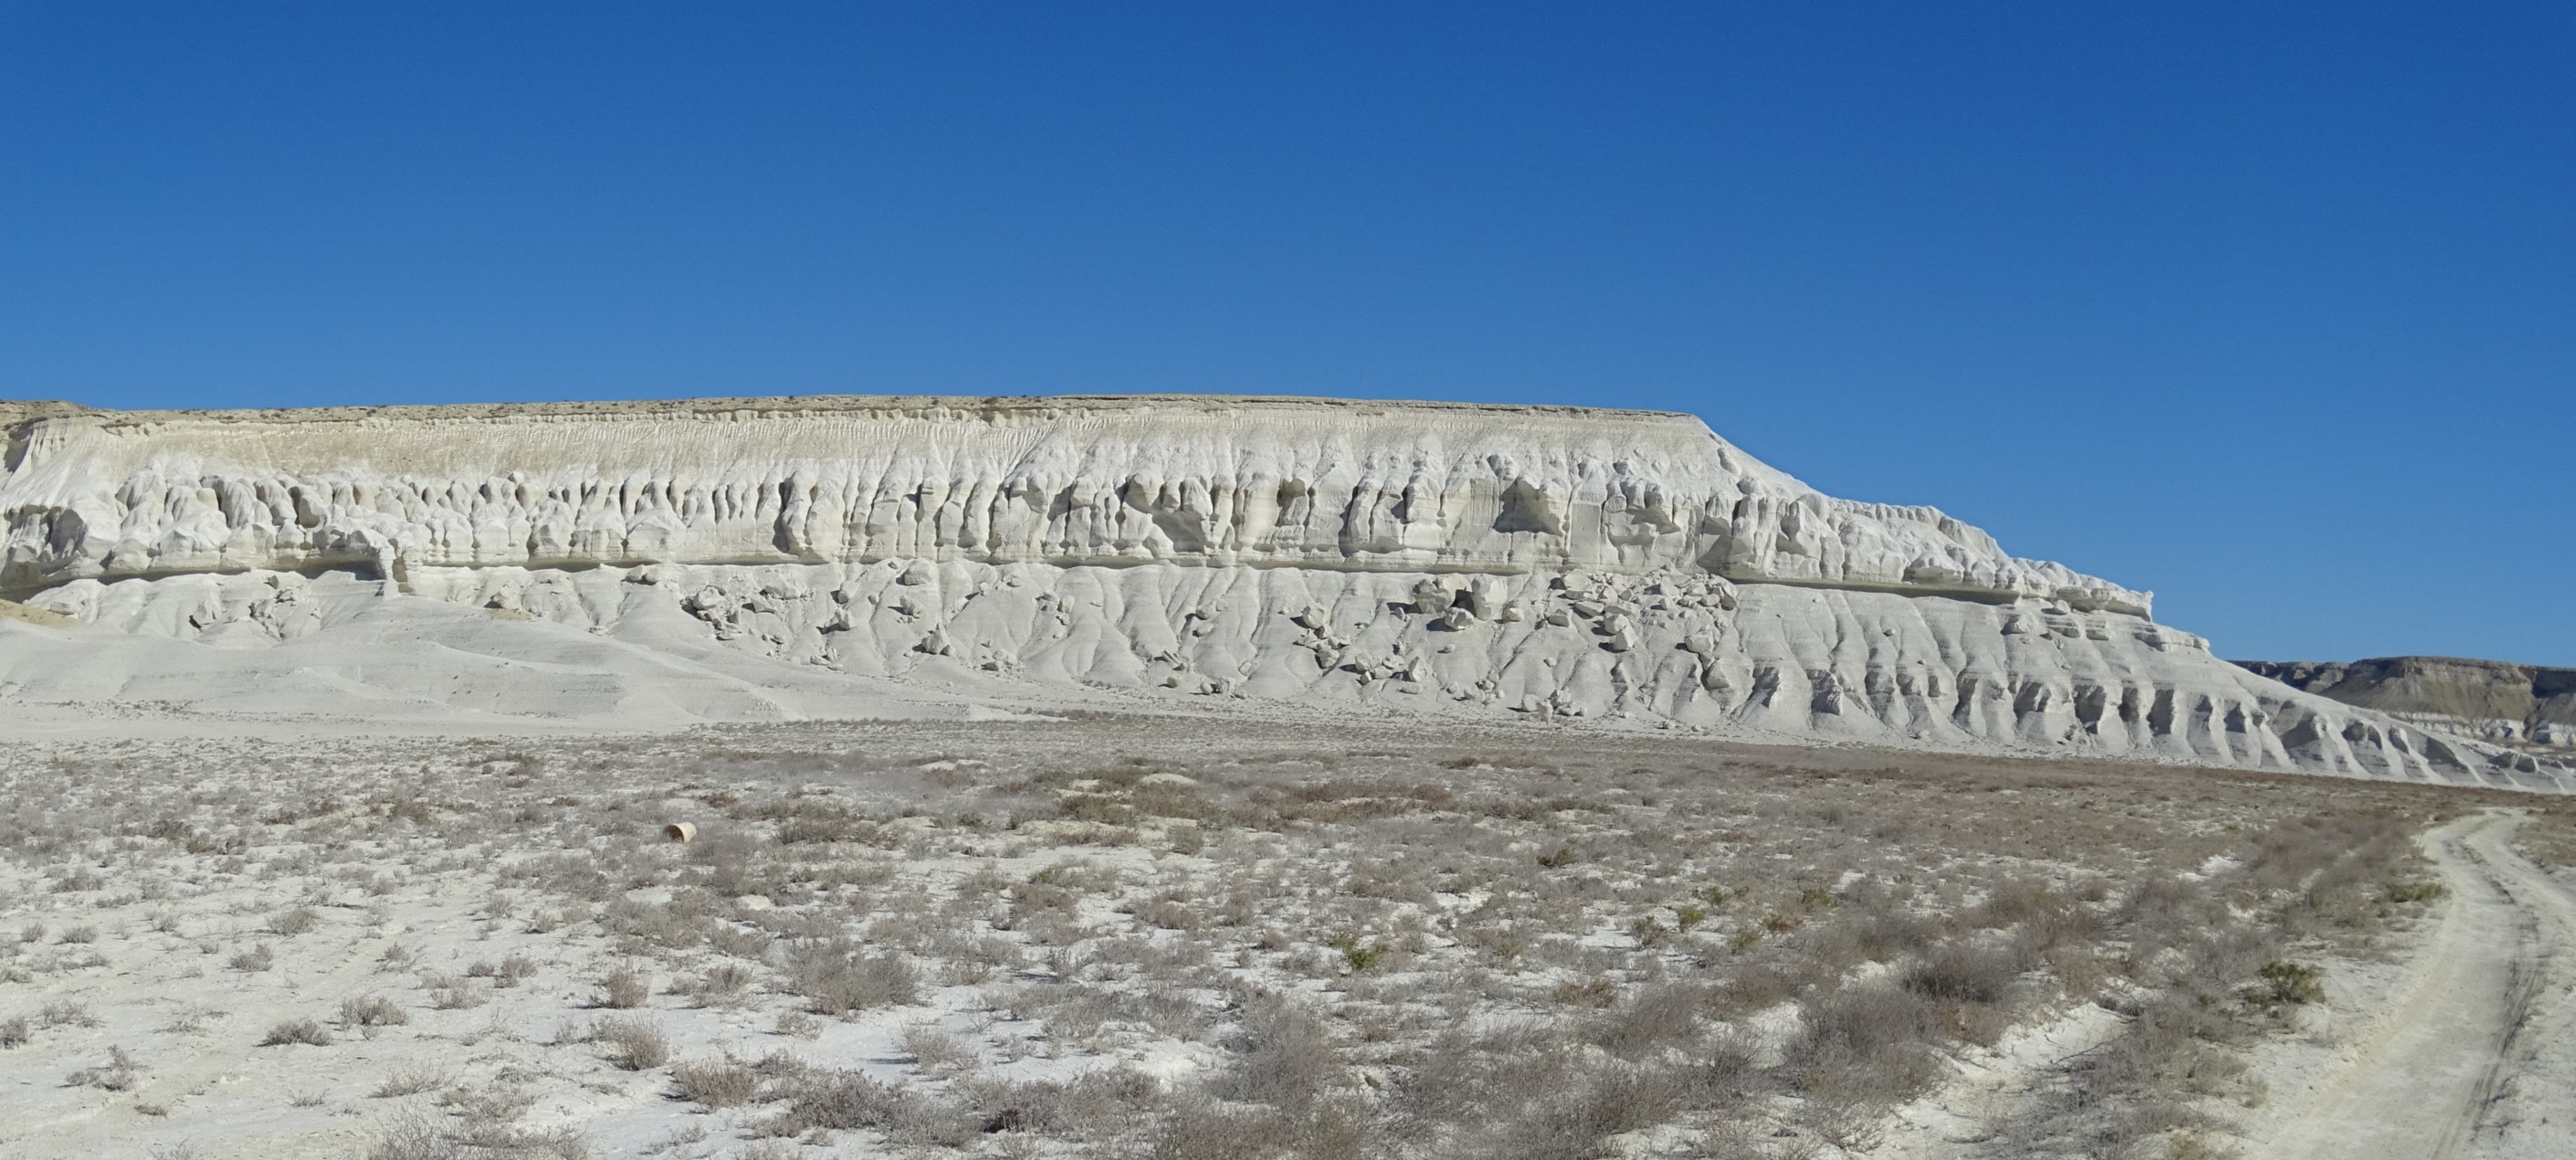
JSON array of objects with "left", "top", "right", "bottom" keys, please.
[{"left": 0, "top": 397, "right": 2569, "bottom": 789}]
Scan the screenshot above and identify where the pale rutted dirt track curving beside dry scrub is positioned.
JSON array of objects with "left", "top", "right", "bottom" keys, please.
[{"left": 2254, "top": 812, "right": 2576, "bottom": 1160}]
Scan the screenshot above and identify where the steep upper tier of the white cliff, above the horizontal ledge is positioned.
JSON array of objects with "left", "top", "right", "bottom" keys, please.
[{"left": 0, "top": 397, "right": 2149, "bottom": 617}]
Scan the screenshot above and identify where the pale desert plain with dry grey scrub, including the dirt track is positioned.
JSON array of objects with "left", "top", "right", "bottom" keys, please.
[{"left": 0, "top": 706, "right": 2576, "bottom": 1160}]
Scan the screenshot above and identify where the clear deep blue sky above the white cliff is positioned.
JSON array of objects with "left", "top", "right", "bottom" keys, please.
[{"left": 0, "top": 0, "right": 2576, "bottom": 665}]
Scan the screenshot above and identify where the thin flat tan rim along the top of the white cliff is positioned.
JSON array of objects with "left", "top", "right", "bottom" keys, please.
[{"left": 0, "top": 395, "right": 1698, "bottom": 426}]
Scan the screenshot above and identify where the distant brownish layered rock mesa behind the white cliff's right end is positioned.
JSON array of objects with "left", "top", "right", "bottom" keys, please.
[{"left": 2238, "top": 658, "right": 2576, "bottom": 750}]
